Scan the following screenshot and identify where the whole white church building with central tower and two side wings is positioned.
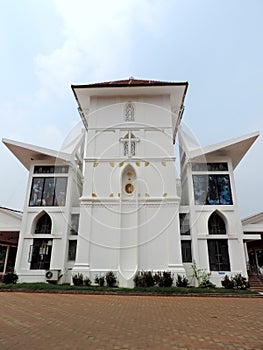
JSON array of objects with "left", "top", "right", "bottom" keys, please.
[{"left": 3, "top": 77, "right": 260, "bottom": 287}]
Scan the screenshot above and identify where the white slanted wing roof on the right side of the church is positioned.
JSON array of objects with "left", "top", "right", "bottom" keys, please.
[{"left": 188, "top": 131, "right": 259, "bottom": 169}]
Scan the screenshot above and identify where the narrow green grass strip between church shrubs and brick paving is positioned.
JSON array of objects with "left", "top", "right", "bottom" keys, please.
[{"left": 0, "top": 283, "right": 258, "bottom": 295}]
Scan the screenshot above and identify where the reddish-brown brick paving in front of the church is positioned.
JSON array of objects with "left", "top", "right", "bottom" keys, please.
[{"left": 0, "top": 293, "right": 263, "bottom": 350}]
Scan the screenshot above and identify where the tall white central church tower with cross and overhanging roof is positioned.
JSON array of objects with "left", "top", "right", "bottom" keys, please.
[{"left": 72, "top": 78, "right": 188, "bottom": 286}]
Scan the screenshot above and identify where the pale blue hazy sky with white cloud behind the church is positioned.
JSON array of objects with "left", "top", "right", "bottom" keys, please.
[{"left": 0, "top": 0, "right": 263, "bottom": 217}]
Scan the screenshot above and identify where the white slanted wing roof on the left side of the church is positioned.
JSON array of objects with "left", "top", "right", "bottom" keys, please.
[{"left": 2, "top": 139, "right": 71, "bottom": 170}]
